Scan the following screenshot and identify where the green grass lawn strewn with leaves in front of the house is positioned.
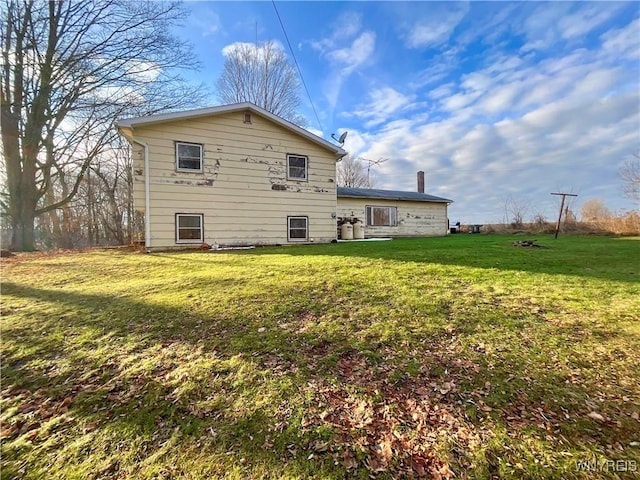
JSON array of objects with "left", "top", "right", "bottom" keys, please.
[{"left": 1, "top": 235, "right": 640, "bottom": 479}]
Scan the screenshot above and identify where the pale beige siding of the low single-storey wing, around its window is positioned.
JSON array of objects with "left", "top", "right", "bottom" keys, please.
[{"left": 338, "top": 197, "right": 447, "bottom": 237}]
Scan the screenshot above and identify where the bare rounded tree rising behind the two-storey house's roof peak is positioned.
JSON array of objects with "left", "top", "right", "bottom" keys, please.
[{"left": 216, "top": 41, "right": 305, "bottom": 125}]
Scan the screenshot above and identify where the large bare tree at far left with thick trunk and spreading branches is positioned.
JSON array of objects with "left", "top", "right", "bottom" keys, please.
[{"left": 0, "top": 0, "right": 204, "bottom": 250}]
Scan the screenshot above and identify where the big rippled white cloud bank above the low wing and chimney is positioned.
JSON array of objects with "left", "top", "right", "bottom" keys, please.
[{"left": 338, "top": 29, "right": 640, "bottom": 223}]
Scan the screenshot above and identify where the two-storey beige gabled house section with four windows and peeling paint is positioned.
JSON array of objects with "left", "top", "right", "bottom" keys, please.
[{"left": 116, "top": 103, "right": 346, "bottom": 250}]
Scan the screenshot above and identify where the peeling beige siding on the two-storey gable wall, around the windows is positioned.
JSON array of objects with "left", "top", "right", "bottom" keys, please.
[{"left": 133, "top": 112, "right": 336, "bottom": 247}]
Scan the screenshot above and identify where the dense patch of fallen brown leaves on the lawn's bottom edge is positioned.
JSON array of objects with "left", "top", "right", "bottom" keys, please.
[{"left": 298, "top": 352, "right": 485, "bottom": 479}]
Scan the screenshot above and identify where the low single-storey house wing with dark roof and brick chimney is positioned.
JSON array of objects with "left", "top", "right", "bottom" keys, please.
[{"left": 337, "top": 172, "right": 452, "bottom": 237}]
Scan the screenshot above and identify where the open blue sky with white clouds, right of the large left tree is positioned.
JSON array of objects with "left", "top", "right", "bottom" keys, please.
[{"left": 172, "top": 1, "right": 640, "bottom": 223}]
